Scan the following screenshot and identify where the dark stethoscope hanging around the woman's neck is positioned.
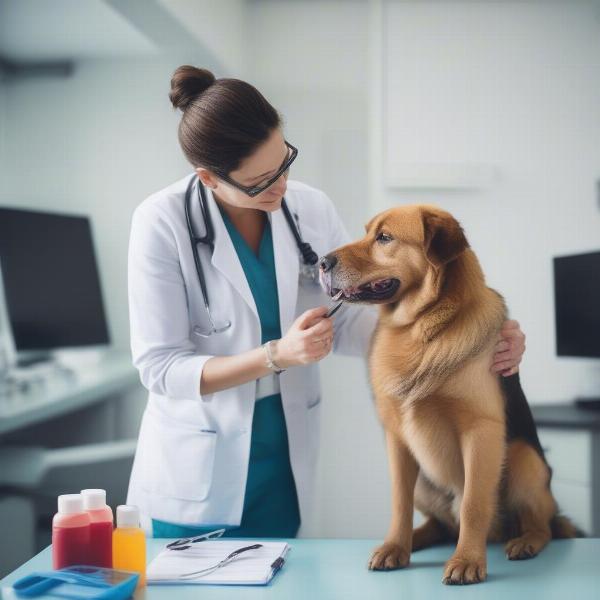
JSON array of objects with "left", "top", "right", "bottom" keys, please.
[{"left": 185, "top": 175, "right": 319, "bottom": 337}]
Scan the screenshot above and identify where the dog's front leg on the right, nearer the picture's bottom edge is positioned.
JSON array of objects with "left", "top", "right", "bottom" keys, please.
[{"left": 442, "top": 421, "right": 504, "bottom": 584}]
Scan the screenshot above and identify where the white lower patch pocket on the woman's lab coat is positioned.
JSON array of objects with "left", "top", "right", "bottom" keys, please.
[{"left": 140, "top": 412, "right": 217, "bottom": 502}]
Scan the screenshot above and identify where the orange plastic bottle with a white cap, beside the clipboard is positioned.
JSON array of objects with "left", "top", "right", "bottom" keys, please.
[{"left": 113, "top": 504, "right": 146, "bottom": 587}]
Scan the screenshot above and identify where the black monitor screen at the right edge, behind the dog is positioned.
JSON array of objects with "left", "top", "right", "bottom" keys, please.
[{"left": 554, "top": 252, "right": 600, "bottom": 357}]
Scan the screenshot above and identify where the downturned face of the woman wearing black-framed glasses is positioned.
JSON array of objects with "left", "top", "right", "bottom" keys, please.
[{"left": 196, "top": 129, "right": 289, "bottom": 212}]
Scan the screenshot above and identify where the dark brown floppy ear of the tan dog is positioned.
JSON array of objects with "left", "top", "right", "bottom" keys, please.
[{"left": 422, "top": 210, "right": 469, "bottom": 267}]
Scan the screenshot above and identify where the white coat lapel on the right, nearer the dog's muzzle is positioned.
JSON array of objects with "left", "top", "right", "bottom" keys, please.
[{"left": 270, "top": 209, "right": 300, "bottom": 335}]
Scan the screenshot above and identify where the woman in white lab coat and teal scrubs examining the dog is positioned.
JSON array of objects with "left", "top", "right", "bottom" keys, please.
[{"left": 128, "top": 66, "right": 524, "bottom": 537}]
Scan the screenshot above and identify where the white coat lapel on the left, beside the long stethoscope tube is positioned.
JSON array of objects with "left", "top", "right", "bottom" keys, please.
[{"left": 207, "top": 190, "right": 258, "bottom": 319}]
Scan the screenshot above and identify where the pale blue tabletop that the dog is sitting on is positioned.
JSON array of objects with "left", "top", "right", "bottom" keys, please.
[{"left": 0, "top": 539, "right": 600, "bottom": 600}]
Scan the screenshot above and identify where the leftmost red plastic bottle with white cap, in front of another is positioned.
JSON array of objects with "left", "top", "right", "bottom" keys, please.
[{"left": 52, "top": 494, "right": 90, "bottom": 569}]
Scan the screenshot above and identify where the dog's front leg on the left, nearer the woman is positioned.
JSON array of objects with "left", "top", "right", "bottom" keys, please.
[{"left": 369, "top": 431, "right": 419, "bottom": 570}]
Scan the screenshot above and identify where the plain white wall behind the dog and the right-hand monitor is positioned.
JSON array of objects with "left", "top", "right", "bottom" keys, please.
[{"left": 371, "top": 1, "right": 600, "bottom": 402}]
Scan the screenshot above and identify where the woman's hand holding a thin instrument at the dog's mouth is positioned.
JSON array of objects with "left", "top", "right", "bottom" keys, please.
[{"left": 273, "top": 306, "right": 333, "bottom": 369}]
